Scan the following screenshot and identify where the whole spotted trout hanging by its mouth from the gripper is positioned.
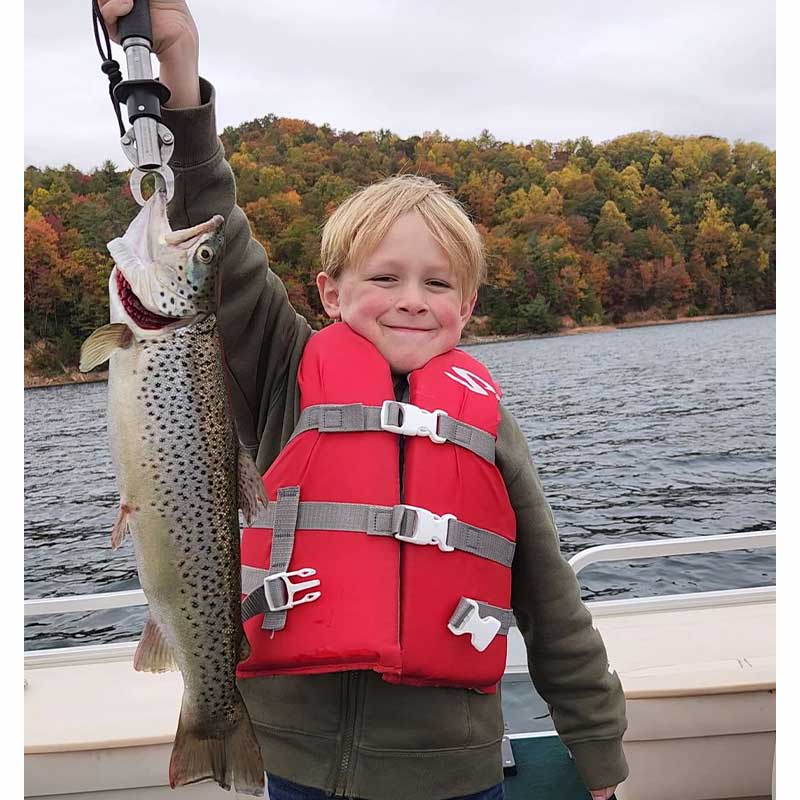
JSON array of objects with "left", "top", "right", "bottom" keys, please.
[{"left": 81, "top": 191, "right": 267, "bottom": 796}]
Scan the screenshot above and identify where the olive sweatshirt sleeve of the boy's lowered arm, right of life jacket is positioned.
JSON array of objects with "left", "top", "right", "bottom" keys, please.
[{"left": 497, "top": 406, "right": 628, "bottom": 789}]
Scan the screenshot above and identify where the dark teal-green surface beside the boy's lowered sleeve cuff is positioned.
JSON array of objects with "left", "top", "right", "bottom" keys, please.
[{"left": 505, "top": 736, "right": 591, "bottom": 800}]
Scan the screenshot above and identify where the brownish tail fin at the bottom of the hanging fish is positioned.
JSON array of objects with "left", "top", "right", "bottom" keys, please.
[{"left": 169, "top": 692, "right": 264, "bottom": 797}]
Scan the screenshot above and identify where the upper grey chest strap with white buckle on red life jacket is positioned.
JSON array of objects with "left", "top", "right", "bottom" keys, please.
[{"left": 290, "top": 400, "right": 495, "bottom": 464}]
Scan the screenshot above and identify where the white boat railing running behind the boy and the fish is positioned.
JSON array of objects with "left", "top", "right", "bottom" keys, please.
[{"left": 25, "top": 530, "right": 776, "bottom": 673}]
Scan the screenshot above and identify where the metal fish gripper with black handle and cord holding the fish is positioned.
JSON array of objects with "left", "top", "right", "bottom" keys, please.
[{"left": 92, "top": 0, "right": 175, "bottom": 206}]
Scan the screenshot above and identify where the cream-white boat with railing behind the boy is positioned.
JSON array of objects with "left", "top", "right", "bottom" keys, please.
[{"left": 24, "top": 531, "right": 776, "bottom": 800}]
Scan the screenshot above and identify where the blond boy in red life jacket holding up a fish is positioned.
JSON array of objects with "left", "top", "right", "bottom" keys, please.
[{"left": 101, "top": 0, "right": 627, "bottom": 800}]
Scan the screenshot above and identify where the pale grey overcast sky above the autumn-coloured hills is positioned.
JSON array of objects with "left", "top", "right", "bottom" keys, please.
[{"left": 25, "top": 0, "right": 775, "bottom": 170}]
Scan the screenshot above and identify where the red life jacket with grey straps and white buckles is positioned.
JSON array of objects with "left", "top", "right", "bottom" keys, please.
[{"left": 237, "top": 323, "right": 516, "bottom": 692}]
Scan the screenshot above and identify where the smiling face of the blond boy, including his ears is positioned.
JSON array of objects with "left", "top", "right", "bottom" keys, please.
[{"left": 317, "top": 211, "right": 477, "bottom": 374}]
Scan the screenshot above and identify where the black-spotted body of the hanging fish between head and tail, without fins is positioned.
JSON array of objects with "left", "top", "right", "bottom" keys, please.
[{"left": 108, "top": 317, "right": 234, "bottom": 704}]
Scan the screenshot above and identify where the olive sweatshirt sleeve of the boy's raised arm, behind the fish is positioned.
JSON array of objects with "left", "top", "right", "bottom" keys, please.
[{"left": 162, "top": 78, "right": 312, "bottom": 472}]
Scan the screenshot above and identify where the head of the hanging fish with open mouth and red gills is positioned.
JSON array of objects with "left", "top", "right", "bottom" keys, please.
[{"left": 108, "top": 191, "right": 225, "bottom": 338}]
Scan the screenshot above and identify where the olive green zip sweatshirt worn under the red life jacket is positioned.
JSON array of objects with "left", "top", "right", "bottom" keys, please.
[{"left": 163, "top": 80, "right": 627, "bottom": 800}]
